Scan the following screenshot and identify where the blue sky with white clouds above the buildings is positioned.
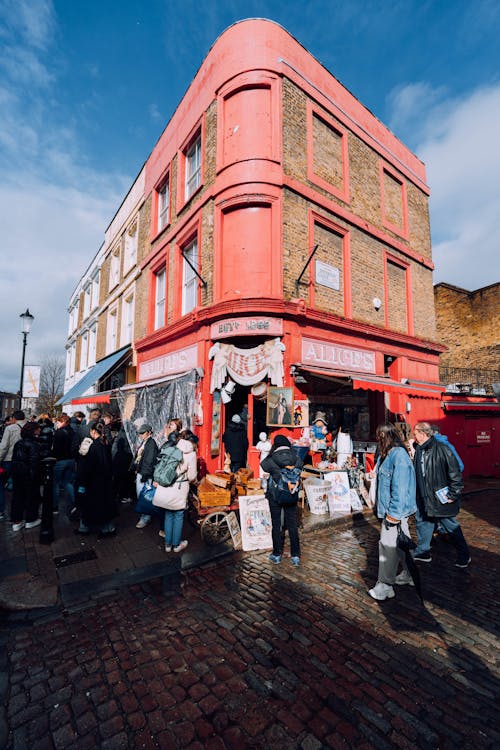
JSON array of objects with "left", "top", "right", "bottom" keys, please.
[{"left": 0, "top": 0, "right": 500, "bottom": 390}]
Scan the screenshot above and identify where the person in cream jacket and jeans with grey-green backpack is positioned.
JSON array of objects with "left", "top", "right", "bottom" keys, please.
[{"left": 153, "top": 425, "right": 198, "bottom": 552}]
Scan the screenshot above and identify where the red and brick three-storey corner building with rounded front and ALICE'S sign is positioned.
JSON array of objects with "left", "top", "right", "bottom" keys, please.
[{"left": 134, "top": 20, "right": 444, "bottom": 470}]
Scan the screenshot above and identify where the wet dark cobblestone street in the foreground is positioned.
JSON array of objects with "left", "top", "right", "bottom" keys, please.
[{"left": 0, "top": 491, "right": 500, "bottom": 750}]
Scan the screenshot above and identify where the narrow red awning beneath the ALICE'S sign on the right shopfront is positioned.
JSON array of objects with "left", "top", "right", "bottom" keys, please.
[{"left": 295, "top": 364, "right": 444, "bottom": 398}]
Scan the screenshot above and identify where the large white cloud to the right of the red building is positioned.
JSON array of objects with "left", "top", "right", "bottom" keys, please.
[{"left": 391, "top": 84, "right": 500, "bottom": 290}]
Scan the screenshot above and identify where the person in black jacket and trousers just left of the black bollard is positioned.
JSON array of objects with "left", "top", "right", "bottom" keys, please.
[{"left": 11, "top": 422, "right": 41, "bottom": 531}]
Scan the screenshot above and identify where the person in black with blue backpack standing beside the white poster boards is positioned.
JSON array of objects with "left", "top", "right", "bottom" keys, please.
[{"left": 260, "top": 435, "right": 303, "bottom": 567}]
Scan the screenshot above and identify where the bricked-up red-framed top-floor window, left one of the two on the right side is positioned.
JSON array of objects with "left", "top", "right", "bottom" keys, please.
[{"left": 307, "top": 102, "right": 349, "bottom": 203}]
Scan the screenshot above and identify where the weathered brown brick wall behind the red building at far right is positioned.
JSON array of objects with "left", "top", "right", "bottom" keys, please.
[{"left": 434, "top": 283, "right": 500, "bottom": 370}]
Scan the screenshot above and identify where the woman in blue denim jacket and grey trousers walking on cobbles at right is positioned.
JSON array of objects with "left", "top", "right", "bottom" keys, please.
[{"left": 368, "top": 424, "right": 417, "bottom": 601}]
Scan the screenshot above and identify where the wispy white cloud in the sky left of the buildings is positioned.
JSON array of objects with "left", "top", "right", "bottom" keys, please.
[{"left": 0, "top": 0, "right": 130, "bottom": 392}]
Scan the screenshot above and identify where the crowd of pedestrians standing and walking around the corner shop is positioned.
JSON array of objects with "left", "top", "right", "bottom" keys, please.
[{"left": 0, "top": 408, "right": 471, "bottom": 588}]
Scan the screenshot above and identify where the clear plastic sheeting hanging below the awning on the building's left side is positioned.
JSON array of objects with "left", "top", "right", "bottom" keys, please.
[{"left": 116, "top": 370, "right": 200, "bottom": 452}]
